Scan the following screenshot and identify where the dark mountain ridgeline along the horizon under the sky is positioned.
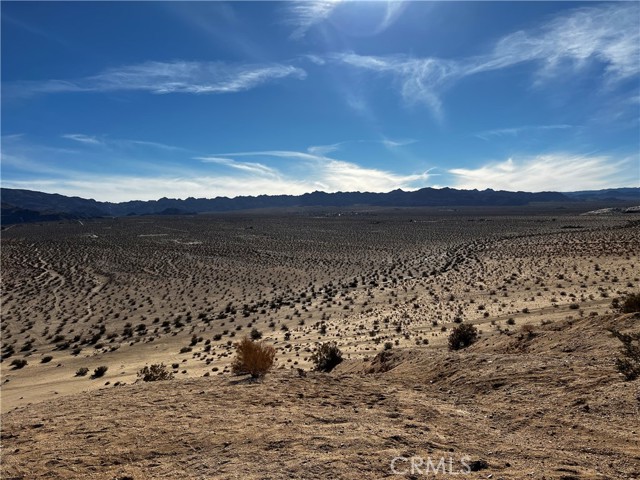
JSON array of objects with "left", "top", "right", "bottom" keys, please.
[{"left": 1, "top": 188, "right": 640, "bottom": 224}]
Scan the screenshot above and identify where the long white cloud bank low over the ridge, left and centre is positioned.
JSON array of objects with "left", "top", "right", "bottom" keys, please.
[{"left": 1, "top": 134, "right": 430, "bottom": 201}]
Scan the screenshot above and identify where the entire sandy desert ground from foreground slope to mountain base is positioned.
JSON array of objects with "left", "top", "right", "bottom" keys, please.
[{"left": 0, "top": 205, "right": 640, "bottom": 480}]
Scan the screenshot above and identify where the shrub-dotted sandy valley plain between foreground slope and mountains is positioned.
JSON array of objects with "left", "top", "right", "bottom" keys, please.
[{"left": 0, "top": 212, "right": 640, "bottom": 412}]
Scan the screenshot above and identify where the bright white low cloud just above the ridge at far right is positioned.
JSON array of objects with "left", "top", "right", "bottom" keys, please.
[{"left": 449, "top": 153, "right": 640, "bottom": 192}]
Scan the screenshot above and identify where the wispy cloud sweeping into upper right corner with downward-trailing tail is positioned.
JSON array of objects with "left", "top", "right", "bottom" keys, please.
[{"left": 327, "top": 2, "right": 640, "bottom": 119}]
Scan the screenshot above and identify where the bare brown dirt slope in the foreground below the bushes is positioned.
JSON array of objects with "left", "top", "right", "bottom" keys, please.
[{"left": 1, "top": 315, "right": 640, "bottom": 480}]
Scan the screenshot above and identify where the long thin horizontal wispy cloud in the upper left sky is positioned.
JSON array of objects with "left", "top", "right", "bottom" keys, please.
[{"left": 3, "top": 61, "right": 306, "bottom": 98}]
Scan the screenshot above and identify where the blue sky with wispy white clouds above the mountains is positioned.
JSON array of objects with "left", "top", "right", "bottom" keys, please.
[{"left": 1, "top": 1, "right": 640, "bottom": 201}]
